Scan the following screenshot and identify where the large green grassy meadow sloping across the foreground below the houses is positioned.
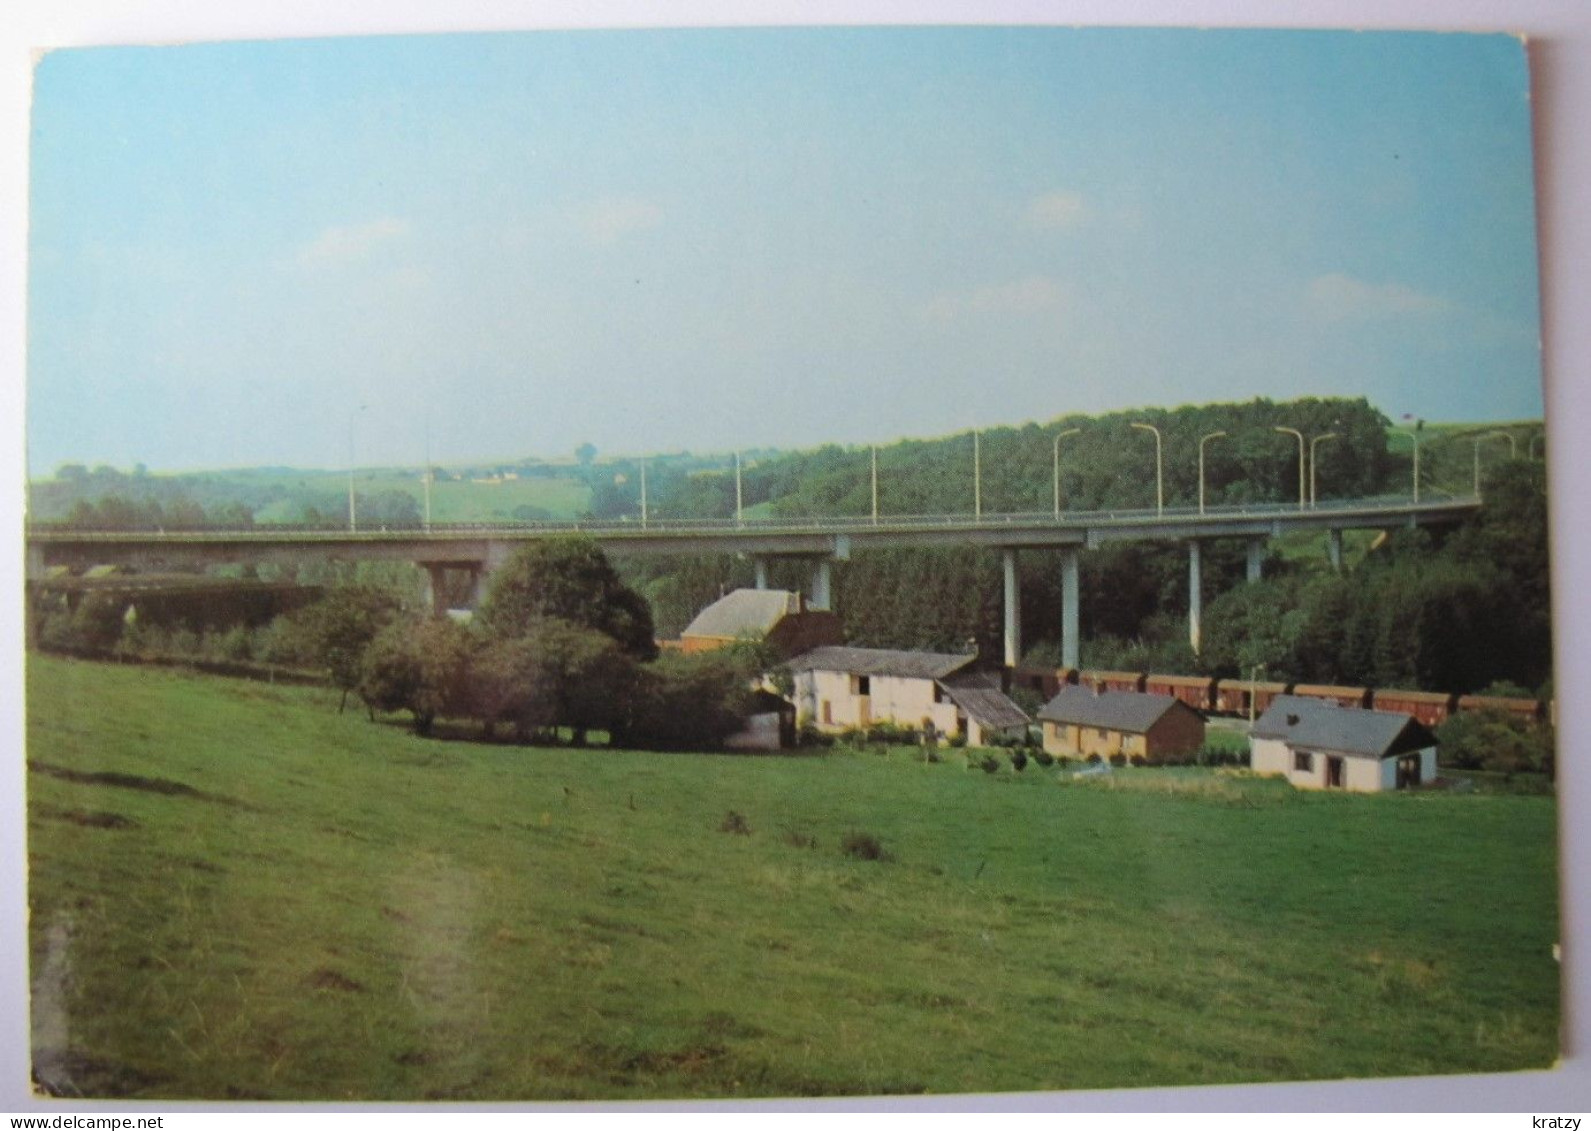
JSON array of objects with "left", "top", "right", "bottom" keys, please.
[{"left": 27, "top": 655, "right": 1558, "bottom": 1099}]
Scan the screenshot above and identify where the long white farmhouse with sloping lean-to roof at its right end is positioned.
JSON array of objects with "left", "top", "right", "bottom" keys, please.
[{"left": 789, "top": 647, "right": 1028, "bottom": 746}]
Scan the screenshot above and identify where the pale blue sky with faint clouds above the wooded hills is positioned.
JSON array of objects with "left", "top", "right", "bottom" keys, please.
[{"left": 27, "top": 27, "right": 1542, "bottom": 476}]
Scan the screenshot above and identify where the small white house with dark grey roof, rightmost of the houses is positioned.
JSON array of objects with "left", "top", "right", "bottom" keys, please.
[{"left": 1249, "top": 695, "right": 1437, "bottom": 792}]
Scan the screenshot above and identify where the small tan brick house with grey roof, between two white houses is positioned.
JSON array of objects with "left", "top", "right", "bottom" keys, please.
[{"left": 1039, "top": 686, "right": 1204, "bottom": 762}]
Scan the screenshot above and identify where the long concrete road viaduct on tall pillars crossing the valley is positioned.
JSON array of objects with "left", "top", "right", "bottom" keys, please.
[{"left": 25, "top": 496, "right": 1480, "bottom": 667}]
